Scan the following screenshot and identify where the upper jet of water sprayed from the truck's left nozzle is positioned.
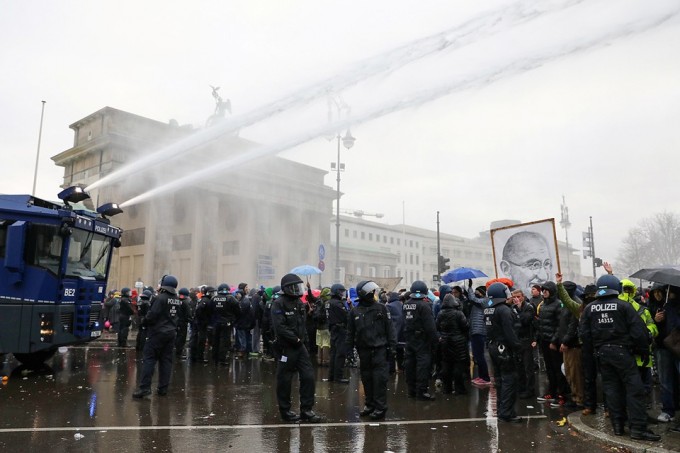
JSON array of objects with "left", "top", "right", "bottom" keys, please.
[{"left": 86, "top": 0, "right": 584, "bottom": 191}]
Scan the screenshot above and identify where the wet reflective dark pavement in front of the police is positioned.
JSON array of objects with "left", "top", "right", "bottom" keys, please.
[{"left": 0, "top": 330, "right": 656, "bottom": 452}]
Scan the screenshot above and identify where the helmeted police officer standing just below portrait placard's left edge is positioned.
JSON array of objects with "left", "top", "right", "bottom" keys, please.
[{"left": 484, "top": 282, "right": 522, "bottom": 423}]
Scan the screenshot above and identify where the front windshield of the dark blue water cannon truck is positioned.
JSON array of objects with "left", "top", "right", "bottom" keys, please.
[{"left": 66, "top": 229, "right": 111, "bottom": 280}]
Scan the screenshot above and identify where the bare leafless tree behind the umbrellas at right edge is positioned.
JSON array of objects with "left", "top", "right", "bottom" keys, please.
[{"left": 617, "top": 212, "right": 680, "bottom": 273}]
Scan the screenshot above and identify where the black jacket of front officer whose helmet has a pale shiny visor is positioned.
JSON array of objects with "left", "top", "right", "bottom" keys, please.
[{"left": 347, "top": 301, "right": 397, "bottom": 351}]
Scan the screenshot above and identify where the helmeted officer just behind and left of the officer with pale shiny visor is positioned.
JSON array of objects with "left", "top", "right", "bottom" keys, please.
[{"left": 328, "top": 283, "right": 349, "bottom": 384}]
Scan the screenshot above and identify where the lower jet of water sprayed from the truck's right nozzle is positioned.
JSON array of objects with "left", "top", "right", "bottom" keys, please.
[{"left": 121, "top": 9, "right": 680, "bottom": 207}]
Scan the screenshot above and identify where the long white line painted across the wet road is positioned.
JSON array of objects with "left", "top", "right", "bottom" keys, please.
[{"left": 0, "top": 415, "right": 547, "bottom": 433}]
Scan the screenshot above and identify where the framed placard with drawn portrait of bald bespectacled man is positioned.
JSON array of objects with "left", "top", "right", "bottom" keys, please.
[{"left": 491, "top": 218, "right": 561, "bottom": 296}]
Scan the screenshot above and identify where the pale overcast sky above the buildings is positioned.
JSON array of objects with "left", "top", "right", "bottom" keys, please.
[{"left": 0, "top": 0, "right": 680, "bottom": 276}]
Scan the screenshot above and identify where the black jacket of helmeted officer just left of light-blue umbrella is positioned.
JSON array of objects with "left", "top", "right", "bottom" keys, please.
[{"left": 271, "top": 294, "right": 307, "bottom": 347}]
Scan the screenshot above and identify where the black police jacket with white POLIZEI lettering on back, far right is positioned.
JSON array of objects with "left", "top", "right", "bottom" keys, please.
[{"left": 579, "top": 295, "right": 649, "bottom": 354}]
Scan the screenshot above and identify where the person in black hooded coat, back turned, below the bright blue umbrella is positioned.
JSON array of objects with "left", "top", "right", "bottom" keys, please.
[{"left": 436, "top": 294, "right": 470, "bottom": 395}]
